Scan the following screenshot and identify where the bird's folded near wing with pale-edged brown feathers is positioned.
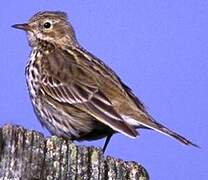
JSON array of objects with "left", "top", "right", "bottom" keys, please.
[{"left": 41, "top": 49, "right": 138, "bottom": 137}]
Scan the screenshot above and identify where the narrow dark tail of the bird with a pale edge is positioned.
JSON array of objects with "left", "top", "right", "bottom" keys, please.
[{"left": 137, "top": 117, "right": 199, "bottom": 148}]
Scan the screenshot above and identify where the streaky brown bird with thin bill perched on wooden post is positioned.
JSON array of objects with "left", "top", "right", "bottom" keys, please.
[{"left": 12, "top": 11, "right": 198, "bottom": 152}]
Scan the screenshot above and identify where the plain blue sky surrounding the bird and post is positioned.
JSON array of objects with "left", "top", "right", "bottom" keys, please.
[{"left": 0, "top": 0, "right": 208, "bottom": 180}]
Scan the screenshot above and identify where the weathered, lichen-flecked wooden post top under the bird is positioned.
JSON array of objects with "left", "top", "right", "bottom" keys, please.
[{"left": 0, "top": 125, "right": 149, "bottom": 180}]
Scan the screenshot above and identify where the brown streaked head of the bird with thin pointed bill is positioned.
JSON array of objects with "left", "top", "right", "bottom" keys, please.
[{"left": 12, "top": 11, "right": 78, "bottom": 47}]
